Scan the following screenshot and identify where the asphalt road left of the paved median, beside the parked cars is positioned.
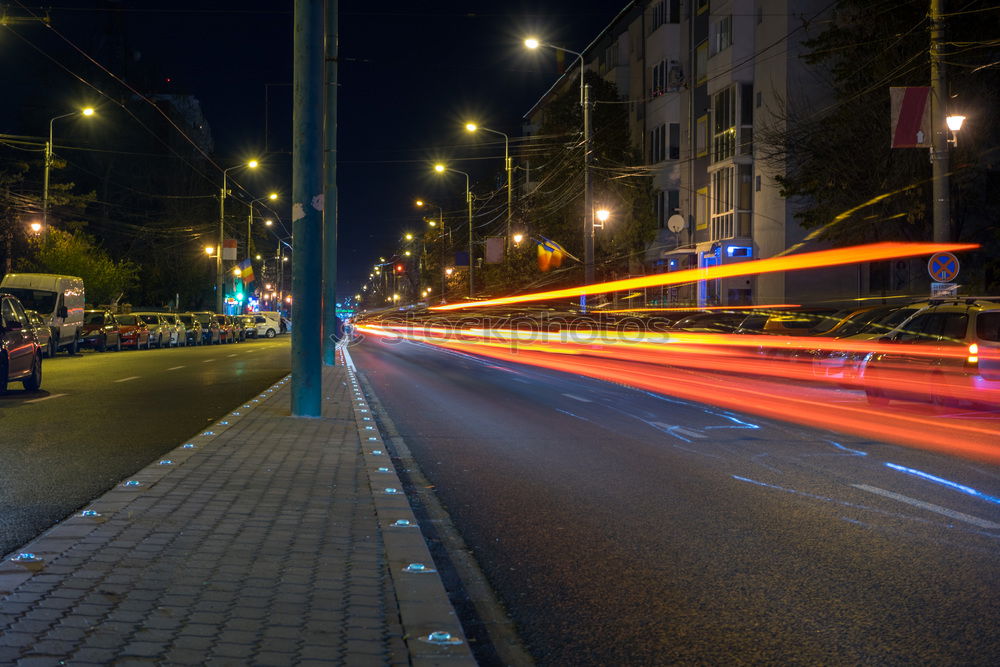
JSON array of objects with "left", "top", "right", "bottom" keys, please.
[{"left": 0, "top": 336, "right": 290, "bottom": 555}]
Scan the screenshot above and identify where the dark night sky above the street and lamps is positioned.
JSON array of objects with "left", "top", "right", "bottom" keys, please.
[{"left": 0, "top": 0, "right": 626, "bottom": 293}]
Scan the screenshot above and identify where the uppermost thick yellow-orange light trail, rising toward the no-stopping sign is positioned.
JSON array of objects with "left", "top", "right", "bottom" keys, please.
[{"left": 429, "top": 242, "right": 979, "bottom": 310}]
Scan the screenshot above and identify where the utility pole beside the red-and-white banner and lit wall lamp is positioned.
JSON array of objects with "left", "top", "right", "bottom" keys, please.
[{"left": 929, "top": 0, "right": 951, "bottom": 243}]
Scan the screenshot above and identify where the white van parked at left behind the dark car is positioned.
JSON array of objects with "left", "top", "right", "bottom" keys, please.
[{"left": 0, "top": 273, "right": 84, "bottom": 354}]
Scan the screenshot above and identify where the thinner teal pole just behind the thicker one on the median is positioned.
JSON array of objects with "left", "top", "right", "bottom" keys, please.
[{"left": 323, "top": 0, "right": 339, "bottom": 366}]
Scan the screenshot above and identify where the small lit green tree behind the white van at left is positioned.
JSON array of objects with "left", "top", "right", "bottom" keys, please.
[{"left": 25, "top": 229, "right": 139, "bottom": 305}]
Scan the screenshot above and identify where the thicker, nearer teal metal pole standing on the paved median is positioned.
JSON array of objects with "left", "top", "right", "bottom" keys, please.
[{"left": 292, "top": 0, "right": 323, "bottom": 417}]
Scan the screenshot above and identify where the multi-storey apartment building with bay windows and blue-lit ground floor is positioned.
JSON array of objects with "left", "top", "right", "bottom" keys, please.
[{"left": 525, "top": 0, "right": 867, "bottom": 305}]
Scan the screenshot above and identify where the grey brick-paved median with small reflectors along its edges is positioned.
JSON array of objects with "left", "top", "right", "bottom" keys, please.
[{"left": 0, "top": 352, "right": 474, "bottom": 666}]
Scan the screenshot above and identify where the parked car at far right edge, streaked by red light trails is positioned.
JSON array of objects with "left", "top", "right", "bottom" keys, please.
[{"left": 864, "top": 298, "right": 1000, "bottom": 407}]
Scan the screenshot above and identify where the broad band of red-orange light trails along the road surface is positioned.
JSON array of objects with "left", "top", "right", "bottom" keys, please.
[{"left": 357, "top": 325, "right": 1000, "bottom": 463}]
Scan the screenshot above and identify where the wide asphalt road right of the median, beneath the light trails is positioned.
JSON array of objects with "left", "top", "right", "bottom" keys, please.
[{"left": 351, "top": 340, "right": 1000, "bottom": 665}]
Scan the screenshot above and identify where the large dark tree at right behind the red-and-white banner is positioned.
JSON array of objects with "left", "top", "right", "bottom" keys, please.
[{"left": 758, "top": 0, "right": 1000, "bottom": 276}]
